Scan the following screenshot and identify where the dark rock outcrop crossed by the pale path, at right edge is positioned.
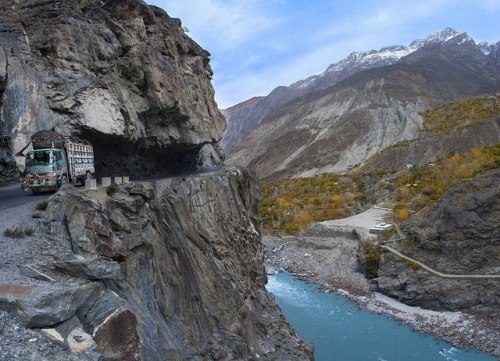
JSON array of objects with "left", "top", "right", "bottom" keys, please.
[{"left": 377, "top": 170, "right": 500, "bottom": 317}]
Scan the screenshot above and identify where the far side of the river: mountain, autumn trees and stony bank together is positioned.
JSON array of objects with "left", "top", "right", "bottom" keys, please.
[{"left": 224, "top": 28, "right": 500, "bottom": 356}]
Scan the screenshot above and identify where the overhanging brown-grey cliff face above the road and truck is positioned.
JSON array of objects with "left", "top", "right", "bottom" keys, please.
[{"left": 0, "top": 0, "right": 225, "bottom": 177}]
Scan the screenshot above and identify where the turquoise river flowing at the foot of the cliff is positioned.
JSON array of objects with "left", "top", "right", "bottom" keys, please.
[{"left": 266, "top": 272, "right": 497, "bottom": 361}]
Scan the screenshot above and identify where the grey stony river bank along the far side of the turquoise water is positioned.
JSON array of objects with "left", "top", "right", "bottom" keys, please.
[{"left": 262, "top": 231, "right": 500, "bottom": 357}]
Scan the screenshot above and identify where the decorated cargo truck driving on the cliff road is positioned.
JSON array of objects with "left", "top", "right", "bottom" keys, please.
[{"left": 21, "top": 130, "right": 95, "bottom": 193}]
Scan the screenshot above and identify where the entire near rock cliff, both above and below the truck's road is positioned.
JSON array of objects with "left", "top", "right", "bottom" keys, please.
[{"left": 0, "top": 0, "right": 313, "bottom": 361}]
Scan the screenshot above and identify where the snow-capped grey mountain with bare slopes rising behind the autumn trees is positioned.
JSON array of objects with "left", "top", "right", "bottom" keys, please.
[{"left": 223, "top": 28, "right": 500, "bottom": 177}]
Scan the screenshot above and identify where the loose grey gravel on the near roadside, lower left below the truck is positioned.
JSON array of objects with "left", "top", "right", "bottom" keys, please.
[{"left": 0, "top": 198, "right": 101, "bottom": 361}]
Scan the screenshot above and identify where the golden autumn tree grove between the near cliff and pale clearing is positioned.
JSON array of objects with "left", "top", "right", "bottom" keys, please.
[{"left": 259, "top": 174, "right": 364, "bottom": 234}]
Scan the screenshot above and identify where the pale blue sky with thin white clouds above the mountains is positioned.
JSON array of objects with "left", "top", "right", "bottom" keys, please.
[{"left": 146, "top": 0, "right": 500, "bottom": 109}]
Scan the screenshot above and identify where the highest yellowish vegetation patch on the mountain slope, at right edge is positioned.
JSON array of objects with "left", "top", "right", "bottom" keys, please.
[{"left": 422, "top": 95, "right": 500, "bottom": 134}]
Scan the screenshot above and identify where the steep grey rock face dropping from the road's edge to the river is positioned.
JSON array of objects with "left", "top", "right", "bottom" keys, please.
[{"left": 41, "top": 169, "right": 312, "bottom": 360}]
